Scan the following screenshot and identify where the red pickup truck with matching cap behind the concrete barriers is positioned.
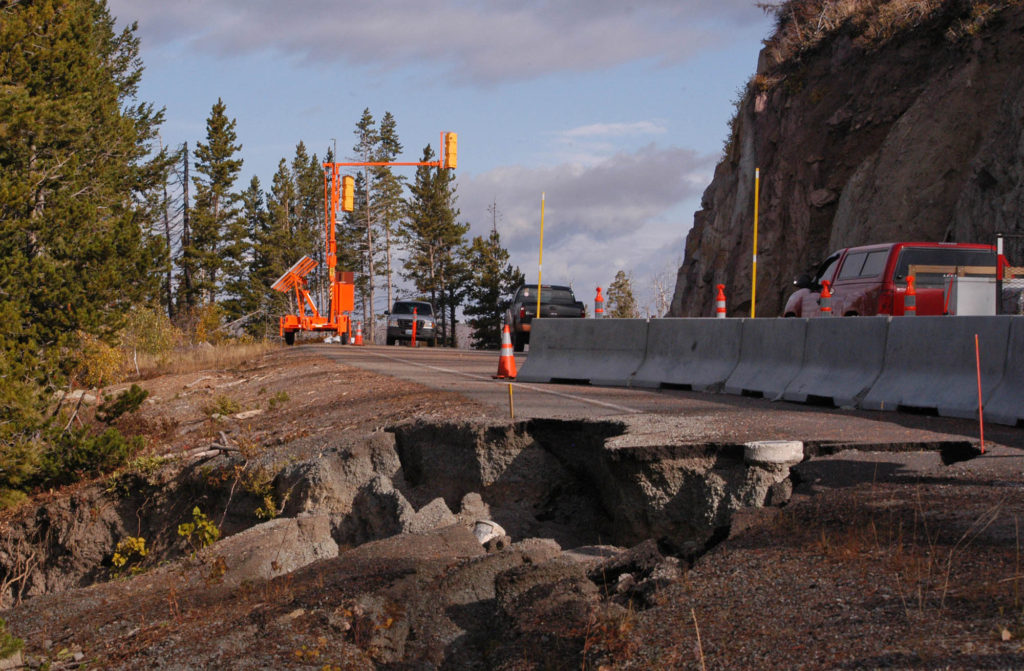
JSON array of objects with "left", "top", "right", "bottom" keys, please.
[{"left": 783, "top": 243, "right": 1006, "bottom": 317}]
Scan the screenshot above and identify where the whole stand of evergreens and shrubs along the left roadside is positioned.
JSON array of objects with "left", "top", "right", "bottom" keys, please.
[{"left": 0, "top": 0, "right": 521, "bottom": 507}]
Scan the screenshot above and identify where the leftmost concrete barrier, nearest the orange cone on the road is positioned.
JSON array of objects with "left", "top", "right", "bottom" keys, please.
[{"left": 516, "top": 319, "right": 647, "bottom": 386}]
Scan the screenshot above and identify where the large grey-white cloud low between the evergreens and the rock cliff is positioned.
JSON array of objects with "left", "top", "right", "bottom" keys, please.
[{"left": 458, "top": 144, "right": 716, "bottom": 302}]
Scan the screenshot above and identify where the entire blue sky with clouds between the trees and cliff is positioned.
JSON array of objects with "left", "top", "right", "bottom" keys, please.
[{"left": 108, "top": 0, "right": 771, "bottom": 314}]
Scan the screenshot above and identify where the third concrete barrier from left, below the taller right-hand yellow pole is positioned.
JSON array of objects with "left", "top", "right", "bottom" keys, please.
[{"left": 725, "top": 318, "right": 807, "bottom": 400}]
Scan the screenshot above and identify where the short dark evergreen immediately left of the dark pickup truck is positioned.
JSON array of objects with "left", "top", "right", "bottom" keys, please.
[{"left": 465, "top": 227, "right": 526, "bottom": 349}]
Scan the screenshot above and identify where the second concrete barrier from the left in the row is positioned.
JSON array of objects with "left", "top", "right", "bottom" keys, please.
[{"left": 633, "top": 319, "right": 742, "bottom": 391}]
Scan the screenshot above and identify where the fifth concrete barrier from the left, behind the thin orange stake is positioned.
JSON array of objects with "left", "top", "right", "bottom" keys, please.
[{"left": 861, "top": 317, "right": 1015, "bottom": 418}]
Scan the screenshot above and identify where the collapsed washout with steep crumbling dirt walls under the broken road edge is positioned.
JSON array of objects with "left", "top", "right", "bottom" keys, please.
[{"left": 0, "top": 418, "right": 792, "bottom": 603}]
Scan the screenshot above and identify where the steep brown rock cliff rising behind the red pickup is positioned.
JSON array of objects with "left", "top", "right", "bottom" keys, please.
[{"left": 670, "top": 0, "right": 1024, "bottom": 317}]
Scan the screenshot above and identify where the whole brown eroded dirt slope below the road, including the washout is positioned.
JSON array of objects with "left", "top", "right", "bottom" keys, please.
[{"left": 0, "top": 351, "right": 1024, "bottom": 670}]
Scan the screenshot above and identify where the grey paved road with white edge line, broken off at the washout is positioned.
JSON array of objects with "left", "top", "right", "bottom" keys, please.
[{"left": 311, "top": 345, "right": 1024, "bottom": 449}]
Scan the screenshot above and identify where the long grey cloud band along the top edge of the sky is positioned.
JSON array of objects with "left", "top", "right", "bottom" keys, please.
[{"left": 109, "top": 0, "right": 761, "bottom": 84}]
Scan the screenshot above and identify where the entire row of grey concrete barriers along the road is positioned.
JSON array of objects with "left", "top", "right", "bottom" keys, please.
[{"left": 517, "top": 317, "right": 1024, "bottom": 425}]
